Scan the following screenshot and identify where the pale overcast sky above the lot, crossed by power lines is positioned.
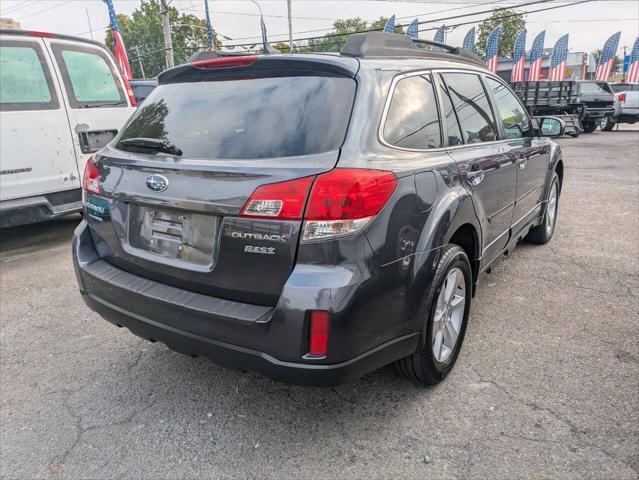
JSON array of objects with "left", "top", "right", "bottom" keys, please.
[{"left": 0, "top": 0, "right": 639, "bottom": 54}]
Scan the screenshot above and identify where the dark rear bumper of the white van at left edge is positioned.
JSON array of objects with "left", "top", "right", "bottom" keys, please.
[{"left": 0, "top": 188, "right": 82, "bottom": 228}]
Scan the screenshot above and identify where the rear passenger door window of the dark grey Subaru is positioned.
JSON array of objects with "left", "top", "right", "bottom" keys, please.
[{"left": 443, "top": 73, "right": 497, "bottom": 143}]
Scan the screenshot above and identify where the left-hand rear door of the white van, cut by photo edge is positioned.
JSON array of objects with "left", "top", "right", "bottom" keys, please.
[{"left": 0, "top": 35, "right": 81, "bottom": 202}]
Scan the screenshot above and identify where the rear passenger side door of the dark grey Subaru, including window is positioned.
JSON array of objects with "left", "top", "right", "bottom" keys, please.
[{"left": 440, "top": 72, "right": 517, "bottom": 266}]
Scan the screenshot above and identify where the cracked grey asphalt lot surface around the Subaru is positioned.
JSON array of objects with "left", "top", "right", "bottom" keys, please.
[{"left": 0, "top": 129, "right": 639, "bottom": 480}]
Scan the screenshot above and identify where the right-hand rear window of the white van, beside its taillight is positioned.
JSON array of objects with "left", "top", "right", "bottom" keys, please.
[{"left": 53, "top": 45, "right": 127, "bottom": 108}]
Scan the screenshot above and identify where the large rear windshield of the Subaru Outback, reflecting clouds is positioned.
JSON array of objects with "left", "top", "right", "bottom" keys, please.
[{"left": 117, "top": 76, "right": 356, "bottom": 159}]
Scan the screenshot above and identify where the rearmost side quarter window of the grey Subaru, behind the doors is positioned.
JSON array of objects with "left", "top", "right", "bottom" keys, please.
[{"left": 384, "top": 75, "right": 441, "bottom": 149}]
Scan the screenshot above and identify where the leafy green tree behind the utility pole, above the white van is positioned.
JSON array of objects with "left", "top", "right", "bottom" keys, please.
[{"left": 105, "top": 0, "right": 220, "bottom": 78}]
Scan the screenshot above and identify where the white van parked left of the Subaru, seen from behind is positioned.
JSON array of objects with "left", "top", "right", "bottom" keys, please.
[{"left": 0, "top": 30, "right": 135, "bottom": 227}]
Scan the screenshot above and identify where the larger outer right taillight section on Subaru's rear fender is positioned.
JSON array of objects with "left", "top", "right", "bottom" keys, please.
[{"left": 302, "top": 168, "right": 397, "bottom": 242}]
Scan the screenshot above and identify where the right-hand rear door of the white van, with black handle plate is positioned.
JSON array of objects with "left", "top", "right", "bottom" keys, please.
[{"left": 45, "top": 38, "right": 135, "bottom": 178}]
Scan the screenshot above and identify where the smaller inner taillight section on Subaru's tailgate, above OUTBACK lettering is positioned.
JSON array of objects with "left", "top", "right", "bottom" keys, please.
[{"left": 240, "top": 177, "right": 315, "bottom": 220}]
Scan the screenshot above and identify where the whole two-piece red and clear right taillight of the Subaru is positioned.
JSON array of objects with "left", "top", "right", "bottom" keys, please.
[{"left": 240, "top": 168, "right": 397, "bottom": 242}]
